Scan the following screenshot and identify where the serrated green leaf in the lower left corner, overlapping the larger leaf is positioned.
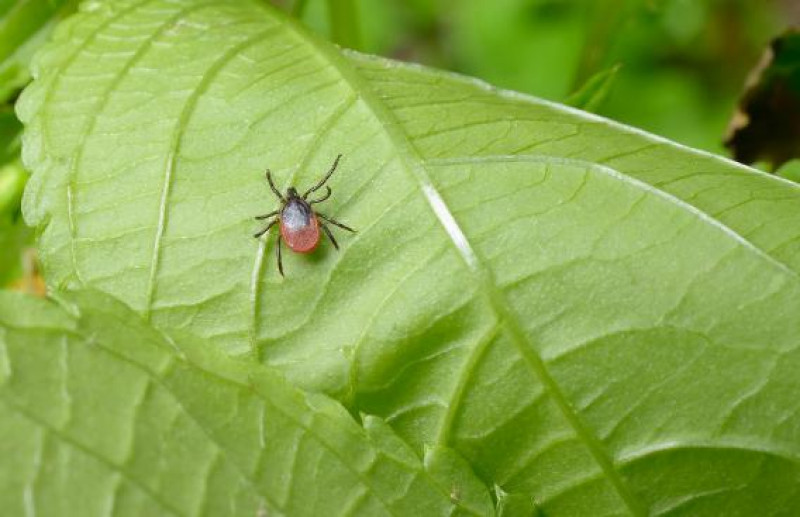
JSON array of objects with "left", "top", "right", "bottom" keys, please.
[{"left": 0, "top": 292, "right": 492, "bottom": 516}]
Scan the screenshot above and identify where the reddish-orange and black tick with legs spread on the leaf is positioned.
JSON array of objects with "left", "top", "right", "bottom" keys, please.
[{"left": 254, "top": 154, "right": 355, "bottom": 276}]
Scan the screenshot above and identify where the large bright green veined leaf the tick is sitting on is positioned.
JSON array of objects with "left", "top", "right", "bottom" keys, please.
[{"left": 20, "top": 0, "right": 800, "bottom": 515}]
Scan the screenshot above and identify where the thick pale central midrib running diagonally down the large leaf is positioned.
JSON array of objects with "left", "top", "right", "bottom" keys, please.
[{"left": 266, "top": 4, "right": 648, "bottom": 516}]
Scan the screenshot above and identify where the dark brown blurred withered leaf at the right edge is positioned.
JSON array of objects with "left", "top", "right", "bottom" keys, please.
[{"left": 727, "top": 30, "right": 800, "bottom": 169}]
